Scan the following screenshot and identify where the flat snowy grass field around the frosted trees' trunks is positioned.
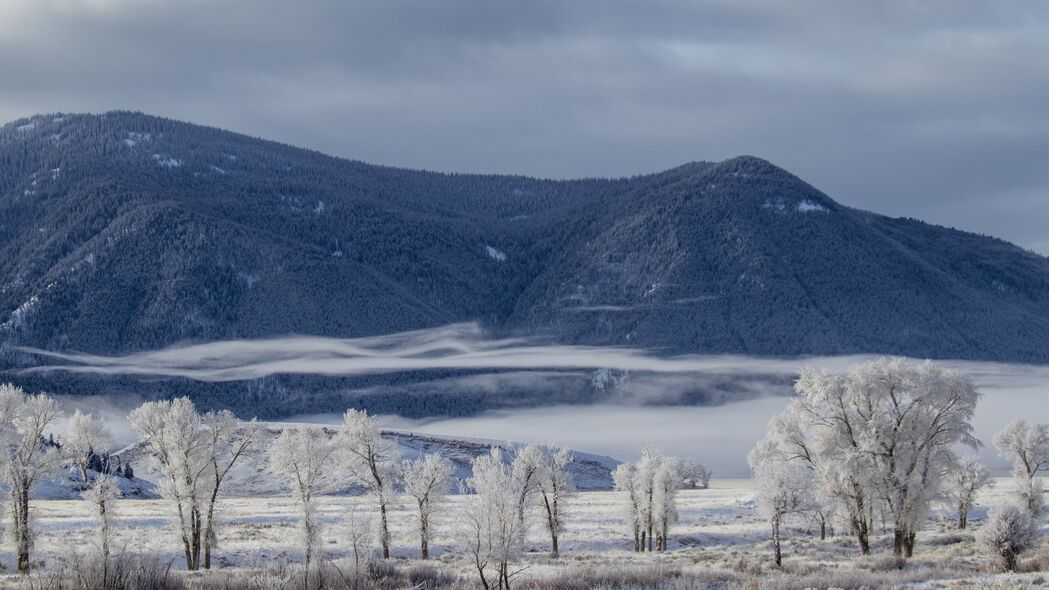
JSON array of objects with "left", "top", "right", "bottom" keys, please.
[{"left": 6, "top": 480, "right": 1049, "bottom": 588}]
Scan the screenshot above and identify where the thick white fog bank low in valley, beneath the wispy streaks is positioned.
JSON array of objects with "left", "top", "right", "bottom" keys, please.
[{"left": 290, "top": 357, "right": 1049, "bottom": 478}]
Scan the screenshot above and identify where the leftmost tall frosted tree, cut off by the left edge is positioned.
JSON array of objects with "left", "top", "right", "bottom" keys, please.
[{"left": 0, "top": 384, "right": 62, "bottom": 573}]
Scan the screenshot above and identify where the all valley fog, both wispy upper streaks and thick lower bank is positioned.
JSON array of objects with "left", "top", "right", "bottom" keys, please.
[{"left": 23, "top": 324, "right": 1049, "bottom": 477}]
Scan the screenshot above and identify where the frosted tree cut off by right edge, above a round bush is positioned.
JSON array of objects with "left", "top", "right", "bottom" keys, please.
[{"left": 994, "top": 420, "right": 1049, "bottom": 517}]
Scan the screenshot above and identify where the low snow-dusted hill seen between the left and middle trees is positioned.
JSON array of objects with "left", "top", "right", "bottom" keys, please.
[{"left": 108, "top": 422, "right": 619, "bottom": 498}]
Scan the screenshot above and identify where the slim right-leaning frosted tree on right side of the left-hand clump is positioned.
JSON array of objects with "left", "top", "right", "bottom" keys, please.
[{"left": 200, "top": 409, "right": 258, "bottom": 569}]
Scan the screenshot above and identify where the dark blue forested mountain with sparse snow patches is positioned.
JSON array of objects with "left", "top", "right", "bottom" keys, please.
[{"left": 0, "top": 112, "right": 1049, "bottom": 413}]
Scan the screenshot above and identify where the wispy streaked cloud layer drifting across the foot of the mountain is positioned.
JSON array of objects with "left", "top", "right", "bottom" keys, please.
[{"left": 17, "top": 323, "right": 849, "bottom": 381}]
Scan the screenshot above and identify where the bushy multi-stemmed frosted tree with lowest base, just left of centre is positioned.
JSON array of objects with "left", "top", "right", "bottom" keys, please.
[{"left": 459, "top": 447, "right": 525, "bottom": 590}]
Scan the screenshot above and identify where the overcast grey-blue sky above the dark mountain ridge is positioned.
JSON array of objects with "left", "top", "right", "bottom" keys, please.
[{"left": 0, "top": 0, "right": 1049, "bottom": 254}]
